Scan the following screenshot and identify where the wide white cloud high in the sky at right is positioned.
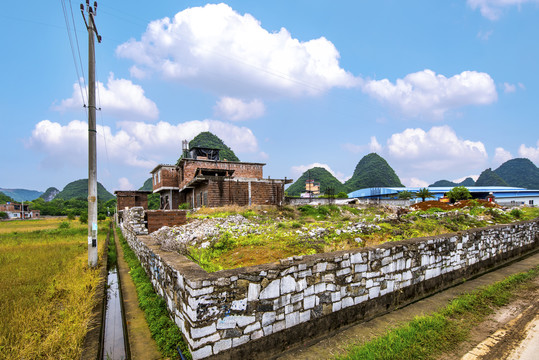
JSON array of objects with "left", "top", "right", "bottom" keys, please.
[{"left": 363, "top": 69, "right": 498, "bottom": 119}]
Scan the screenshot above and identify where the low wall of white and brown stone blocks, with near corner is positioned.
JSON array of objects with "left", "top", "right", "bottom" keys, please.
[{"left": 123, "top": 210, "right": 539, "bottom": 359}]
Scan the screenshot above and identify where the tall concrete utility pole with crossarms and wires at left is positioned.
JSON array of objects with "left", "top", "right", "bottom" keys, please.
[{"left": 80, "top": 0, "right": 101, "bottom": 267}]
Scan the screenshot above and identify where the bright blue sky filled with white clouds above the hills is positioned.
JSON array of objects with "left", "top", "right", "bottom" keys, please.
[{"left": 0, "top": 0, "right": 539, "bottom": 192}]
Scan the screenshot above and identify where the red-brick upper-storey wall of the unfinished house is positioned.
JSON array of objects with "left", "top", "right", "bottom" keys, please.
[{"left": 179, "top": 159, "right": 264, "bottom": 188}]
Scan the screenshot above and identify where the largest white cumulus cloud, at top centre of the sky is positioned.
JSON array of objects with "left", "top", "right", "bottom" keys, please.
[{"left": 116, "top": 3, "right": 359, "bottom": 97}]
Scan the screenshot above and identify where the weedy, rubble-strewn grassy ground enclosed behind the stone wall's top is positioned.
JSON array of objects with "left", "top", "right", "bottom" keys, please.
[{"left": 189, "top": 203, "right": 539, "bottom": 272}]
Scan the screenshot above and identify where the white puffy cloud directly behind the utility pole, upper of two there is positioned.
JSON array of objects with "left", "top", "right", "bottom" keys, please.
[{"left": 53, "top": 73, "right": 159, "bottom": 120}]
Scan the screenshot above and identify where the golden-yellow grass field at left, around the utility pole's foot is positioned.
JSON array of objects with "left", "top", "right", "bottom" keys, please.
[{"left": 0, "top": 219, "right": 107, "bottom": 359}]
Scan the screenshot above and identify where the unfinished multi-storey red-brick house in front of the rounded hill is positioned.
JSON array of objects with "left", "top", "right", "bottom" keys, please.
[{"left": 151, "top": 147, "right": 292, "bottom": 209}]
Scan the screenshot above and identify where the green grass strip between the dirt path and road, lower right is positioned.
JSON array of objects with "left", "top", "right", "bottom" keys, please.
[{"left": 337, "top": 266, "right": 539, "bottom": 360}]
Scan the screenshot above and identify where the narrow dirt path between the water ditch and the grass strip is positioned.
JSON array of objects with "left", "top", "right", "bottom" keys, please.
[{"left": 114, "top": 230, "right": 161, "bottom": 360}]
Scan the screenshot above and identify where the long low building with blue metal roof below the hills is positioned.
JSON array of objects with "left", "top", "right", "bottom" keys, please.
[{"left": 348, "top": 186, "right": 539, "bottom": 206}]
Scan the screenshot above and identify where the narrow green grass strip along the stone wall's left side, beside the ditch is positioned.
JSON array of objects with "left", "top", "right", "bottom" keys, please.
[{"left": 117, "top": 229, "right": 191, "bottom": 359}]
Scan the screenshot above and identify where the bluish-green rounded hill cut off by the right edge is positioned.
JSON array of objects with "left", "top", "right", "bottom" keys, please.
[{"left": 494, "top": 158, "right": 539, "bottom": 189}]
